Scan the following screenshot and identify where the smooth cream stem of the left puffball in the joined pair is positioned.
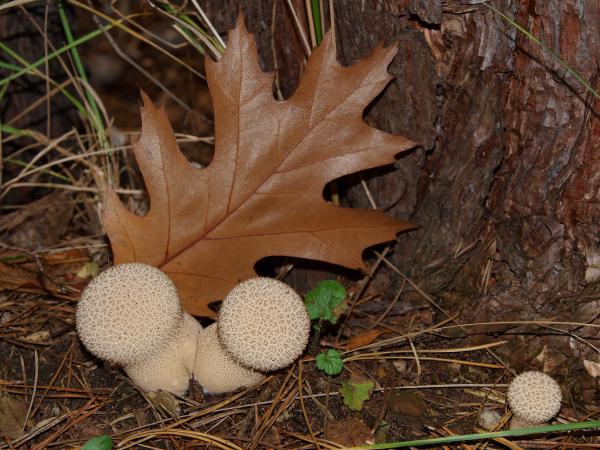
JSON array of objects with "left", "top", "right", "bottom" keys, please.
[{"left": 125, "top": 313, "right": 202, "bottom": 395}]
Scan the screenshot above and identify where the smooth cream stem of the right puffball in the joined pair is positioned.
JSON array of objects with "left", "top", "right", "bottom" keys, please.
[{"left": 194, "top": 323, "right": 265, "bottom": 394}]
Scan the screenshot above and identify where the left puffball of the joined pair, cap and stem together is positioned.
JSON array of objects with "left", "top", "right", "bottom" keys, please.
[{"left": 76, "top": 263, "right": 202, "bottom": 395}]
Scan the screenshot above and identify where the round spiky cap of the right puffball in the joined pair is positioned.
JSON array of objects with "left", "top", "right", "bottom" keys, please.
[{"left": 217, "top": 277, "right": 310, "bottom": 372}]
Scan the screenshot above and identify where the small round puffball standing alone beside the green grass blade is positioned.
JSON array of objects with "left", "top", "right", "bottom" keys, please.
[{"left": 507, "top": 371, "right": 562, "bottom": 428}]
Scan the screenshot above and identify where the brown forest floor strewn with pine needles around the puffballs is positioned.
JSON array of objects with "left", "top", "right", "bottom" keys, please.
[{"left": 0, "top": 250, "right": 597, "bottom": 449}]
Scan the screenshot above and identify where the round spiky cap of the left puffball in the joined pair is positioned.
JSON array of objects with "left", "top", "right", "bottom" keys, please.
[{"left": 76, "top": 263, "right": 183, "bottom": 365}]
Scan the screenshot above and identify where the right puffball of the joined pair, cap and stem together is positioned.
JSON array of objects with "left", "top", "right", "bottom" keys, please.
[{"left": 194, "top": 277, "right": 310, "bottom": 394}]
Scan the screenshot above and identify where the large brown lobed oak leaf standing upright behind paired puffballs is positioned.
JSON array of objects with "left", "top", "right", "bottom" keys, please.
[{"left": 103, "top": 15, "right": 415, "bottom": 316}]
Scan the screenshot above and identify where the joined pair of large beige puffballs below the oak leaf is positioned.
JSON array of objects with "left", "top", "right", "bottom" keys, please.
[{"left": 76, "top": 263, "right": 310, "bottom": 395}]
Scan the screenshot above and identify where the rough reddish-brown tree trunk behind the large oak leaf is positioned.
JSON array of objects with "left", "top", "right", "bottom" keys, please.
[{"left": 205, "top": 0, "right": 600, "bottom": 370}]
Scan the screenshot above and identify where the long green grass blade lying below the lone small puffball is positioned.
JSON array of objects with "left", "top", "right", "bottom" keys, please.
[{"left": 357, "top": 420, "right": 600, "bottom": 449}]
